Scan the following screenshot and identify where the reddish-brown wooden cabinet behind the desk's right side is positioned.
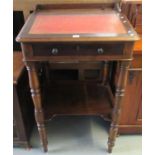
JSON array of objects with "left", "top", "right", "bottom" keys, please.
[{"left": 119, "top": 1, "right": 142, "bottom": 134}]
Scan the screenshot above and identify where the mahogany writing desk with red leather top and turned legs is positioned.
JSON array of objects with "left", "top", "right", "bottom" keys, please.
[{"left": 17, "top": 4, "right": 139, "bottom": 152}]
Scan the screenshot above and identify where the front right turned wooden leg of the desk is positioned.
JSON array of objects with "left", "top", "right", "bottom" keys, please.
[{"left": 108, "top": 61, "right": 129, "bottom": 153}]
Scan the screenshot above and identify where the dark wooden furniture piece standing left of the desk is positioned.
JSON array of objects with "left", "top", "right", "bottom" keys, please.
[{"left": 13, "top": 52, "right": 34, "bottom": 148}]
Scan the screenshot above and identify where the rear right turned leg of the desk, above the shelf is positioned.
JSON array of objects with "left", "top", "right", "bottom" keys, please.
[{"left": 101, "top": 61, "right": 109, "bottom": 85}]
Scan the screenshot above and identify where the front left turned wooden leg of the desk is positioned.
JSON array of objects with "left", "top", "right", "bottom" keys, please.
[{"left": 26, "top": 62, "right": 47, "bottom": 152}]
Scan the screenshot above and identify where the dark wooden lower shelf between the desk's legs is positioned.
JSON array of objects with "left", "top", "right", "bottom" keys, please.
[{"left": 43, "top": 83, "right": 113, "bottom": 120}]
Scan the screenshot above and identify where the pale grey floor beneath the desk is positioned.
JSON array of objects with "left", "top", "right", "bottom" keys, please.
[{"left": 13, "top": 116, "right": 142, "bottom": 155}]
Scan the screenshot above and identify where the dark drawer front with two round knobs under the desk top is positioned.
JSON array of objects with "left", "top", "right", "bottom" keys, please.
[{"left": 32, "top": 43, "right": 124, "bottom": 56}]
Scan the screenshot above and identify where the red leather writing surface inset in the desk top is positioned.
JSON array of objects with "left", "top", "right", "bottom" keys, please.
[{"left": 29, "top": 14, "right": 126, "bottom": 34}]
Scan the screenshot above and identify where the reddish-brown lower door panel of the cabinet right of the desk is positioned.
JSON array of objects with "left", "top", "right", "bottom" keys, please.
[{"left": 120, "top": 70, "right": 142, "bottom": 126}]
